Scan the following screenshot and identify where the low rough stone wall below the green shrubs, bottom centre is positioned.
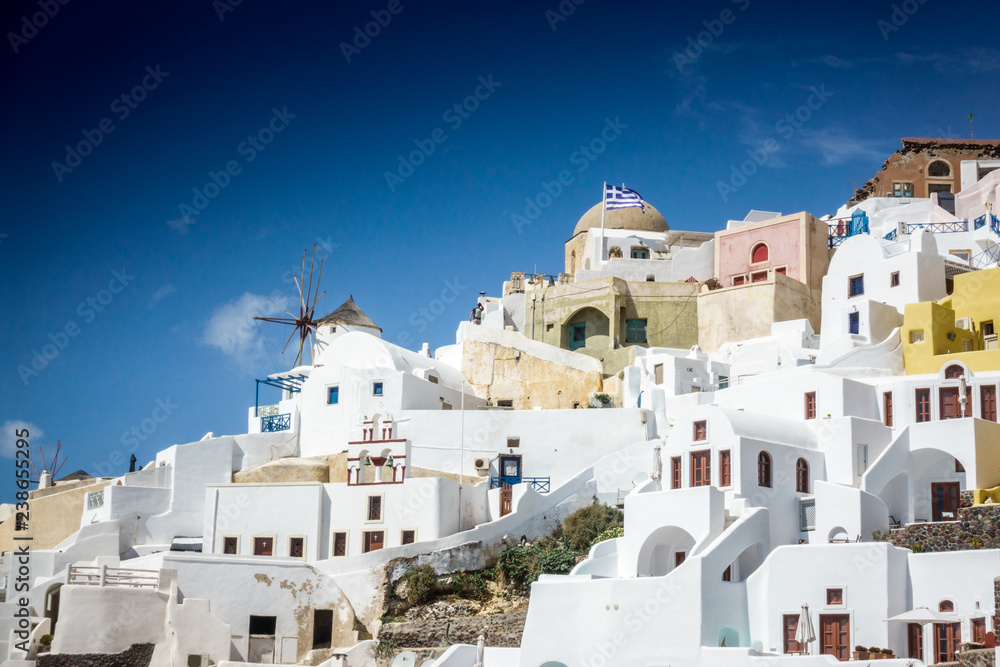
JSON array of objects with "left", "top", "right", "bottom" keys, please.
[{"left": 379, "top": 612, "right": 528, "bottom": 648}]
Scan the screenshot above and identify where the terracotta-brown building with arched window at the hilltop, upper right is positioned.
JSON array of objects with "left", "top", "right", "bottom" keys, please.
[{"left": 850, "top": 137, "right": 1000, "bottom": 204}]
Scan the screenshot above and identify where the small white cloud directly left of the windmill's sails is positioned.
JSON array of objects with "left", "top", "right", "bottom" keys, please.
[{"left": 199, "top": 292, "right": 291, "bottom": 368}]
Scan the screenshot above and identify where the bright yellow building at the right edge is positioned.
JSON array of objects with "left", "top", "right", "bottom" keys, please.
[{"left": 899, "top": 269, "right": 1000, "bottom": 375}]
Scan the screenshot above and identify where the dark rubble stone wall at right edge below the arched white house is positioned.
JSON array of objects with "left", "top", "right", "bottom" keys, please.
[{"left": 888, "top": 504, "right": 1000, "bottom": 552}]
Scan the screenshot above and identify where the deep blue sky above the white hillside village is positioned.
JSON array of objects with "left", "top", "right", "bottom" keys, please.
[{"left": 0, "top": 0, "right": 1000, "bottom": 499}]
